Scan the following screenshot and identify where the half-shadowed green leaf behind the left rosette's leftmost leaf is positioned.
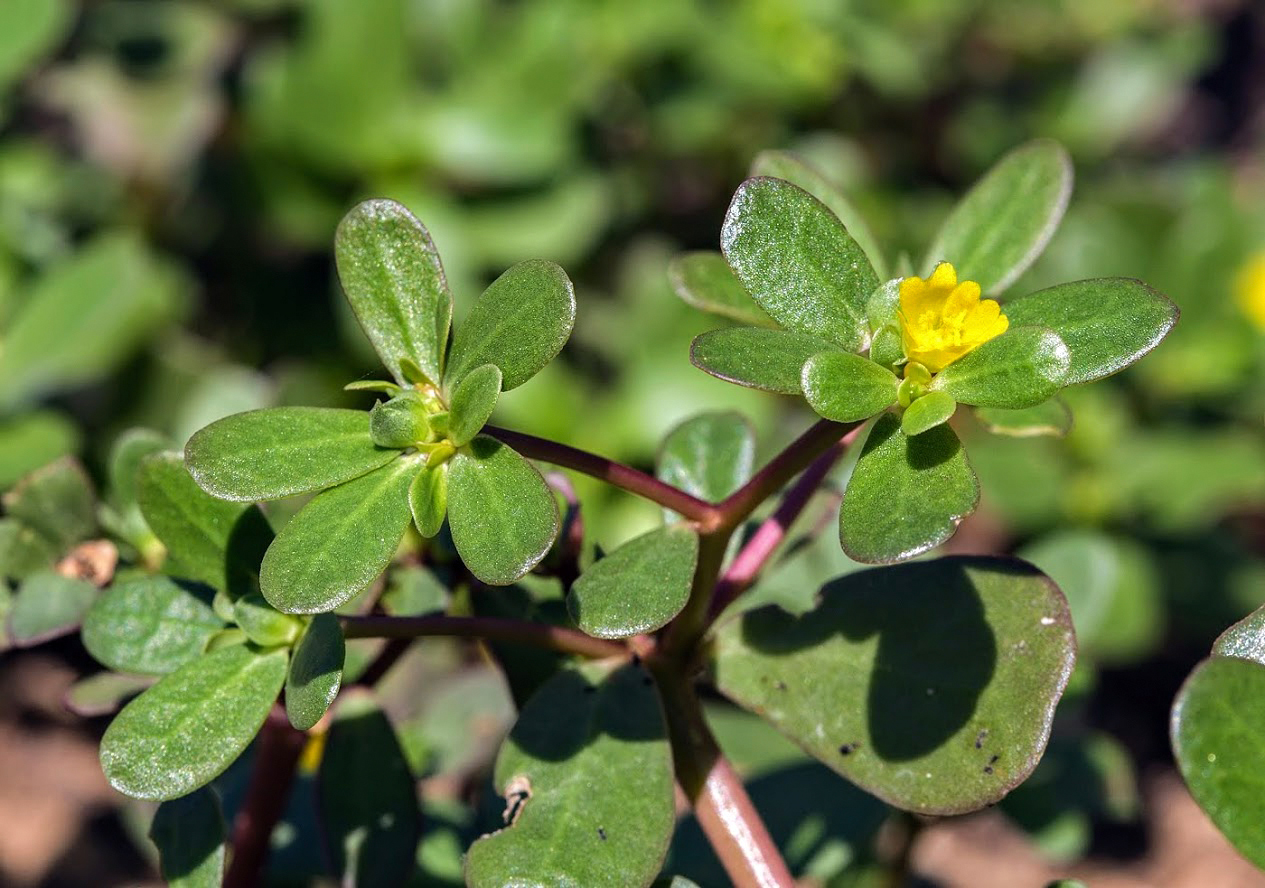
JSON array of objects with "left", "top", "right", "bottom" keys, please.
[{"left": 137, "top": 452, "right": 272, "bottom": 595}]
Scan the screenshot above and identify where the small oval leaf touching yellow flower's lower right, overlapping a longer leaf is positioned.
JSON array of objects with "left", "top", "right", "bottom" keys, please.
[{"left": 931, "top": 326, "right": 1071, "bottom": 410}]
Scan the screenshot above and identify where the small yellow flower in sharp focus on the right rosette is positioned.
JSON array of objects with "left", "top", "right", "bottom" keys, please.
[{"left": 899, "top": 262, "right": 1009, "bottom": 373}]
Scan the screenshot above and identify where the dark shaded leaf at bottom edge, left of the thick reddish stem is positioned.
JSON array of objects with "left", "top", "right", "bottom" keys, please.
[{"left": 149, "top": 787, "right": 226, "bottom": 888}]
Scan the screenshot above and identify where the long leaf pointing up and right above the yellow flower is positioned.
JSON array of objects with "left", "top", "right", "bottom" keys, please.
[{"left": 922, "top": 139, "right": 1071, "bottom": 292}]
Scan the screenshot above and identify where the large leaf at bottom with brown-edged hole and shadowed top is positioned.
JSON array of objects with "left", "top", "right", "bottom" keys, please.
[{"left": 466, "top": 664, "right": 676, "bottom": 888}]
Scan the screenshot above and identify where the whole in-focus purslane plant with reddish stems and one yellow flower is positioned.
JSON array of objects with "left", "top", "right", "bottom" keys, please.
[{"left": 76, "top": 143, "right": 1176, "bottom": 887}]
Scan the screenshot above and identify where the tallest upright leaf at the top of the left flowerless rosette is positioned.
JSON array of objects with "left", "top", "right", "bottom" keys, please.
[{"left": 334, "top": 200, "right": 453, "bottom": 386}]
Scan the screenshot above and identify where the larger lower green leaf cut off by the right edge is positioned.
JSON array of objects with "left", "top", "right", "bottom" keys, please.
[{"left": 1170, "top": 657, "right": 1265, "bottom": 866}]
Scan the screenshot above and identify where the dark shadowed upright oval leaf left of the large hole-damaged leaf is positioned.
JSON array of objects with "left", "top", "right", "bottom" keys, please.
[{"left": 316, "top": 688, "right": 421, "bottom": 888}]
